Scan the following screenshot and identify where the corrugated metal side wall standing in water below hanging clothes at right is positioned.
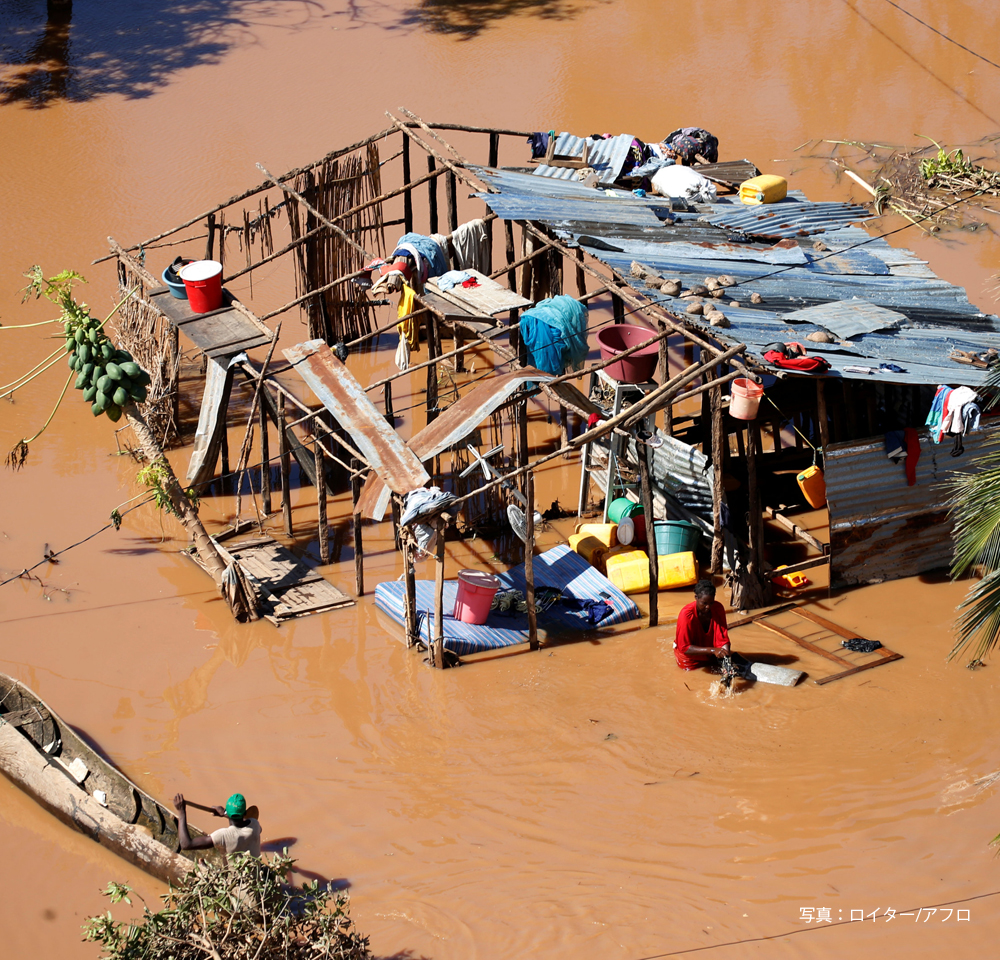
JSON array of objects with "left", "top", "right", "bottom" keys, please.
[{"left": 825, "top": 424, "right": 1000, "bottom": 583}]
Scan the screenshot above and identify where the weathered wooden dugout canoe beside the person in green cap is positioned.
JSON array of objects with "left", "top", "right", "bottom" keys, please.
[{"left": 0, "top": 673, "right": 214, "bottom": 882}]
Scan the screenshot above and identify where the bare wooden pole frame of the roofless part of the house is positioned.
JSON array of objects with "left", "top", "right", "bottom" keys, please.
[{"left": 107, "top": 109, "right": 780, "bottom": 666}]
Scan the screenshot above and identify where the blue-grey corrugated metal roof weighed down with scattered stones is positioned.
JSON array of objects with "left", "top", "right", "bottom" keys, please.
[{"left": 476, "top": 168, "right": 1000, "bottom": 387}]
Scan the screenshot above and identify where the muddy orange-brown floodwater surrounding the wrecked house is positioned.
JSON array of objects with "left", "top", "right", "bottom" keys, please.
[{"left": 0, "top": 0, "right": 1000, "bottom": 960}]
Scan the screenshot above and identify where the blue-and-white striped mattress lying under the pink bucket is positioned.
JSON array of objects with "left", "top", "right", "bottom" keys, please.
[{"left": 375, "top": 544, "right": 639, "bottom": 656}]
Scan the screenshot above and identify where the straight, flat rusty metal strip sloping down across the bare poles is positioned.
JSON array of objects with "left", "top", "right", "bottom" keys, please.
[{"left": 282, "top": 340, "right": 430, "bottom": 494}]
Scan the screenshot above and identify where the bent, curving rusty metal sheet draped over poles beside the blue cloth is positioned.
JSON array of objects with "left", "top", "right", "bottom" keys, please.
[{"left": 358, "top": 367, "right": 554, "bottom": 520}]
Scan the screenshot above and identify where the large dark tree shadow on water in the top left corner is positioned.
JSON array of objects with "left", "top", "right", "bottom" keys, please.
[{"left": 0, "top": 0, "right": 325, "bottom": 109}]
